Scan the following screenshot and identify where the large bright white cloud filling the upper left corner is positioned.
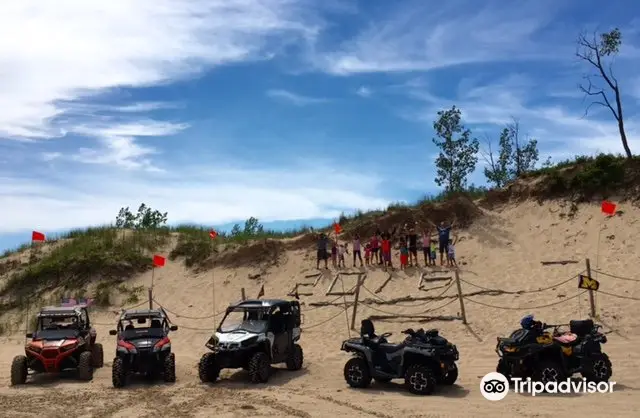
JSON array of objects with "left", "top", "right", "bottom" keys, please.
[{"left": 0, "top": 0, "right": 320, "bottom": 165}]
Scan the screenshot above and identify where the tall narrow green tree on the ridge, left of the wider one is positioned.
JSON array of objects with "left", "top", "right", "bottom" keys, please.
[{"left": 433, "top": 106, "right": 479, "bottom": 193}]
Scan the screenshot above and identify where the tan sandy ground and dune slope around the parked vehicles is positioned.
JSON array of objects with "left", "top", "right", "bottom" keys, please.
[{"left": 0, "top": 203, "right": 640, "bottom": 417}]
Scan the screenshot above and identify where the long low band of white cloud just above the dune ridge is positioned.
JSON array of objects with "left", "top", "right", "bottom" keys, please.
[{"left": 0, "top": 161, "right": 391, "bottom": 233}]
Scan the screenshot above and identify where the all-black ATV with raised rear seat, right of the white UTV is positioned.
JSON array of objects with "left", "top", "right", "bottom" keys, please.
[{"left": 341, "top": 319, "right": 459, "bottom": 395}]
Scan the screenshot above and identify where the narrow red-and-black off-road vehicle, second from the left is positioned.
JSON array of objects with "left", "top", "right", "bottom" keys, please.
[{"left": 109, "top": 309, "right": 178, "bottom": 388}]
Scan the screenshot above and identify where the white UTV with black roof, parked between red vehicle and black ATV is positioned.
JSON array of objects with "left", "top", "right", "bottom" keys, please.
[{"left": 198, "top": 299, "right": 304, "bottom": 383}]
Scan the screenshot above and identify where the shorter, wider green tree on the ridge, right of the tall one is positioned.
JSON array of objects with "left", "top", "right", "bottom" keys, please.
[{"left": 482, "top": 119, "right": 539, "bottom": 187}]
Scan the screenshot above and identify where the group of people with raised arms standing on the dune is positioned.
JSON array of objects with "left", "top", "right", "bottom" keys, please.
[{"left": 316, "top": 219, "right": 457, "bottom": 270}]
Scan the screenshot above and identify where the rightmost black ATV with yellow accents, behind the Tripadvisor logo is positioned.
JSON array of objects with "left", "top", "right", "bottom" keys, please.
[{"left": 496, "top": 319, "right": 612, "bottom": 383}]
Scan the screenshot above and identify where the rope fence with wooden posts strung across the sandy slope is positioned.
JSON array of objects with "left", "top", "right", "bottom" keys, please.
[{"left": 86, "top": 259, "right": 640, "bottom": 333}]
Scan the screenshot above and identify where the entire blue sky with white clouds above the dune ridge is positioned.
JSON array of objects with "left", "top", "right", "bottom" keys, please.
[{"left": 0, "top": 0, "right": 640, "bottom": 248}]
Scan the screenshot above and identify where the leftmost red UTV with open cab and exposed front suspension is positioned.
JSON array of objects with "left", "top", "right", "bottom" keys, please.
[{"left": 11, "top": 305, "right": 104, "bottom": 385}]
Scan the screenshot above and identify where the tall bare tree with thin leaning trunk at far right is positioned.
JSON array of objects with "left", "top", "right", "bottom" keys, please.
[{"left": 576, "top": 28, "right": 633, "bottom": 158}]
